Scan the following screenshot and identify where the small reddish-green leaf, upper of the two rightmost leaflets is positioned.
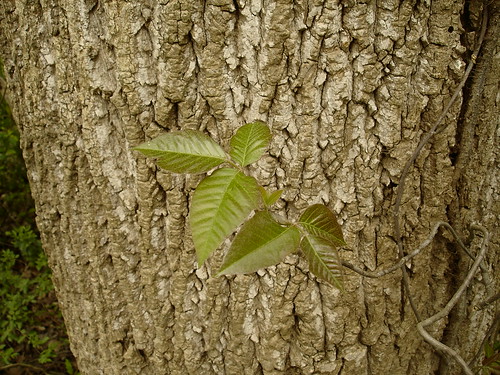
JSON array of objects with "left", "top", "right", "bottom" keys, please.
[{"left": 299, "top": 204, "right": 346, "bottom": 246}]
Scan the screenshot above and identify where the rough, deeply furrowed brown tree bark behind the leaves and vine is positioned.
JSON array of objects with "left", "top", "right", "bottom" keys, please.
[{"left": 0, "top": 0, "right": 500, "bottom": 375}]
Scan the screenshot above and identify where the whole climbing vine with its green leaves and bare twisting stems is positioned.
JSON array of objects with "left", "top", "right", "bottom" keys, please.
[{"left": 131, "top": 4, "right": 498, "bottom": 375}]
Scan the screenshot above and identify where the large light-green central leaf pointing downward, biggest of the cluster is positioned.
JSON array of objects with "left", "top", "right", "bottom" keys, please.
[{"left": 189, "top": 168, "right": 260, "bottom": 266}]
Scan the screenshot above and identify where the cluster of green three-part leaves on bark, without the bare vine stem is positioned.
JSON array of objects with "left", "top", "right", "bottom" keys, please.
[{"left": 134, "top": 121, "right": 345, "bottom": 289}]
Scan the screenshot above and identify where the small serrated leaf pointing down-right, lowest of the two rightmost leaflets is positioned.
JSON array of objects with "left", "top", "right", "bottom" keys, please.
[{"left": 300, "top": 234, "right": 344, "bottom": 290}]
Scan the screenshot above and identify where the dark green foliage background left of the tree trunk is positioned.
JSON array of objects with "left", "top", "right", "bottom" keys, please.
[{"left": 0, "top": 66, "right": 77, "bottom": 375}]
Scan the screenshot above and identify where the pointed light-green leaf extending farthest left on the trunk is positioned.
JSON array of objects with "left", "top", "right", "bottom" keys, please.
[{"left": 134, "top": 130, "right": 227, "bottom": 173}]
